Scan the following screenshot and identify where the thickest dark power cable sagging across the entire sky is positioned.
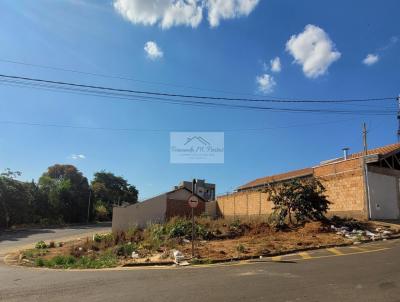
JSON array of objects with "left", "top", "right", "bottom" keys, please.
[{"left": 0, "top": 74, "right": 397, "bottom": 103}]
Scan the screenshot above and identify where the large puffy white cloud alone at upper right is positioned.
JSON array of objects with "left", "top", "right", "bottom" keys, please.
[{"left": 286, "top": 24, "right": 341, "bottom": 78}]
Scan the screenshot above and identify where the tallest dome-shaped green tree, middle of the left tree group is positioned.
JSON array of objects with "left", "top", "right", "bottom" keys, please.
[{"left": 39, "top": 164, "right": 89, "bottom": 222}]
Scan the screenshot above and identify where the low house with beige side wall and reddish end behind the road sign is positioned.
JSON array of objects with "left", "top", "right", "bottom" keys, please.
[{"left": 112, "top": 187, "right": 216, "bottom": 232}]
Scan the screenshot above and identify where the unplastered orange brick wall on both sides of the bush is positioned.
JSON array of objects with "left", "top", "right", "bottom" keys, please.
[{"left": 217, "top": 159, "right": 367, "bottom": 218}]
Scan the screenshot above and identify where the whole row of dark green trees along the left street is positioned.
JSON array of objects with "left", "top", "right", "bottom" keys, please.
[{"left": 0, "top": 165, "right": 138, "bottom": 229}]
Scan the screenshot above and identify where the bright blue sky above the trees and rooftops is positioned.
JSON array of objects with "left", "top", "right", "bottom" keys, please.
[{"left": 0, "top": 0, "right": 400, "bottom": 199}]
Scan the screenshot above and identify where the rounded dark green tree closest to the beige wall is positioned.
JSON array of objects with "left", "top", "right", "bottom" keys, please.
[{"left": 91, "top": 171, "right": 139, "bottom": 218}]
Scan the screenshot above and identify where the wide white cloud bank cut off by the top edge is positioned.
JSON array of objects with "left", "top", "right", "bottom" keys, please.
[{"left": 114, "top": 0, "right": 260, "bottom": 29}]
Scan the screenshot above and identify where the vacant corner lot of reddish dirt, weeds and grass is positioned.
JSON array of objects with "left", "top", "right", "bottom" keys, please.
[{"left": 19, "top": 215, "right": 396, "bottom": 268}]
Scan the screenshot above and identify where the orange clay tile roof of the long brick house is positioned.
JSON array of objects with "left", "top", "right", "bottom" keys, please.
[{"left": 237, "top": 143, "right": 400, "bottom": 190}]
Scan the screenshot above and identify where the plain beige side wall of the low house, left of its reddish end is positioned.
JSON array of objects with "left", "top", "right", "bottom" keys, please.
[{"left": 112, "top": 194, "right": 167, "bottom": 232}]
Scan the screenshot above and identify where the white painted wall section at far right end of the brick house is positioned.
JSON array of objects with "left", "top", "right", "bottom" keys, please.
[{"left": 368, "top": 172, "right": 400, "bottom": 219}]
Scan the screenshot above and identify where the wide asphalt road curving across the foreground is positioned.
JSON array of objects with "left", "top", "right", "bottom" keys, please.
[{"left": 0, "top": 240, "right": 400, "bottom": 302}]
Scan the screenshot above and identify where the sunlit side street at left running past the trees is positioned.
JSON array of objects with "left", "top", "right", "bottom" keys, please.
[{"left": 0, "top": 223, "right": 111, "bottom": 260}]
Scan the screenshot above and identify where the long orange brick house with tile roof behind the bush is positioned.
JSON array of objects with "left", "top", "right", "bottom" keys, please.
[{"left": 217, "top": 144, "right": 400, "bottom": 219}]
